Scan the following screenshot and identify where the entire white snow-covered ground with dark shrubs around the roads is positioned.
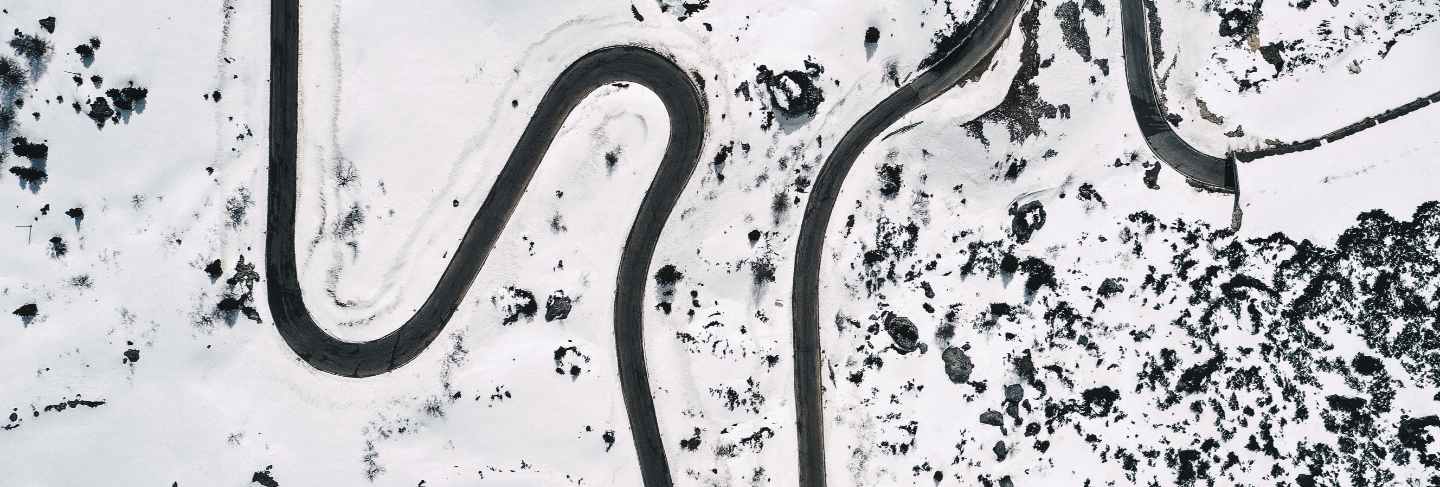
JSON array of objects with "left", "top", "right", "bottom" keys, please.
[{"left": 0, "top": 0, "right": 1440, "bottom": 486}]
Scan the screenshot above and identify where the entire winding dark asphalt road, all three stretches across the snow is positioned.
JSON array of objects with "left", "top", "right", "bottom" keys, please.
[{"left": 265, "top": 0, "right": 1430, "bottom": 487}]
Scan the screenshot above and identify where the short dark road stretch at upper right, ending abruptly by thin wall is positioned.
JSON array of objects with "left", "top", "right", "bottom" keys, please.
[{"left": 1120, "top": 0, "right": 1240, "bottom": 193}]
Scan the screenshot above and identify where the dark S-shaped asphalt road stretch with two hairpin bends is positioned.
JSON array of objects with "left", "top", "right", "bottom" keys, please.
[{"left": 265, "top": 0, "right": 706, "bottom": 487}]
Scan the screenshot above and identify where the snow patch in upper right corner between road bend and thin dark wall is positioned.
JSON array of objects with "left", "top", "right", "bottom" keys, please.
[{"left": 1156, "top": 0, "right": 1440, "bottom": 154}]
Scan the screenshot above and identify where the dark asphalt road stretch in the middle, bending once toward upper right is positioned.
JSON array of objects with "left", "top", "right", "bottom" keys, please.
[{"left": 791, "top": 0, "right": 1028, "bottom": 487}]
